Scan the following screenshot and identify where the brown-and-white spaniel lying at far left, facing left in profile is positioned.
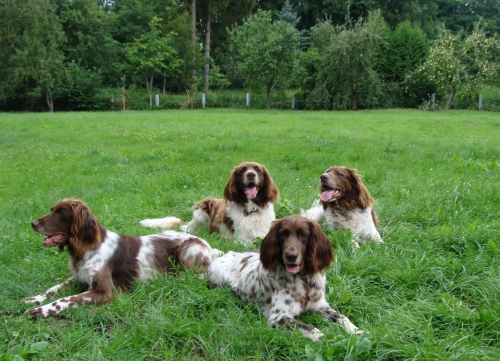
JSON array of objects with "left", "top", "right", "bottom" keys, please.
[{"left": 24, "top": 198, "right": 218, "bottom": 317}]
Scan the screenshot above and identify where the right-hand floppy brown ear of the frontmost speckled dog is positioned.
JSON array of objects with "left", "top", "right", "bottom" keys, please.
[{"left": 305, "top": 219, "right": 334, "bottom": 273}]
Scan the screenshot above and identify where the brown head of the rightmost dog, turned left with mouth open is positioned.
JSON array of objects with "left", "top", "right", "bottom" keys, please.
[{"left": 319, "top": 166, "right": 375, "bottom": 209}]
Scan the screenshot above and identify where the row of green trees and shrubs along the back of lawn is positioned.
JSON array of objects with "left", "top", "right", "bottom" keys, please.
[{"left": 0, "top": 0, "right": 500, "bottom": 111}]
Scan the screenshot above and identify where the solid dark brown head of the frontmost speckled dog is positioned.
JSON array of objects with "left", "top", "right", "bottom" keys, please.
[{"left": 260, "top": 216, "right": 333, "bottom": 275}]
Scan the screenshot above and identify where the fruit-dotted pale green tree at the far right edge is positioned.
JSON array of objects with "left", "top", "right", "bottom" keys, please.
[{"left": 412, "top": 23, "right": 500, "bottom": 109}]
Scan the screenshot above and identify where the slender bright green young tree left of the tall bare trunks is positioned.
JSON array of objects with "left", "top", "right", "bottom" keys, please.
[{"left": 126, "top": 17, "right": 182, "bottom": 108}]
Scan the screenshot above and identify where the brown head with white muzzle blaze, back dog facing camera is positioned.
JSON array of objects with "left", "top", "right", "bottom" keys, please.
[{"left": 224, "top": 162, "right": 280, "bottom": 207}]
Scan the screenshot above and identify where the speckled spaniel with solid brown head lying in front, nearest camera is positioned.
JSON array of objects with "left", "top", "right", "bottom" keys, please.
[{"left": 207, "top": 216, "right": 363, "bottom": 341}]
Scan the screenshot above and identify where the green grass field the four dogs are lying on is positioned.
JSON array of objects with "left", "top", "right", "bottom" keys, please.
[{"left": 0, "top": 110, "right": 500, "bottom": 360}]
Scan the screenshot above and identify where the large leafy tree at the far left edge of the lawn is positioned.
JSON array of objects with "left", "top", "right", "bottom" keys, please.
[{"left": 0, "top": 0, "right": 65, "bottom": 112}]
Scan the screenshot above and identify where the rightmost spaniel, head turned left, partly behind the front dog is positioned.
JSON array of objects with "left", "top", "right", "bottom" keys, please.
[{"left": 302, "top": 166, "right": 384, "bottom": 247}]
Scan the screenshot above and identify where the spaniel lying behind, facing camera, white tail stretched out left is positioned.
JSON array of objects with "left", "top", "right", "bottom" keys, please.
[{"left": 141, "top": 162, "right": 280, "bottom": 246}]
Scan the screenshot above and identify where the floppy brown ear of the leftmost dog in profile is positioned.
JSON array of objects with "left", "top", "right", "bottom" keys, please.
[{"left": 70, "top": 200, "right": 101, "bottom": 257}]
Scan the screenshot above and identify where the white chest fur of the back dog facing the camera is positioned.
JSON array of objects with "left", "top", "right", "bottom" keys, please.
[{"left": 225, "top": 201, "right": 276, "bottom": 246}]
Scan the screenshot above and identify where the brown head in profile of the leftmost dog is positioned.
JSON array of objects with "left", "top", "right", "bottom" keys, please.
[{"left": 31, "top": 198, "right": 102, "bottom": 257}]
